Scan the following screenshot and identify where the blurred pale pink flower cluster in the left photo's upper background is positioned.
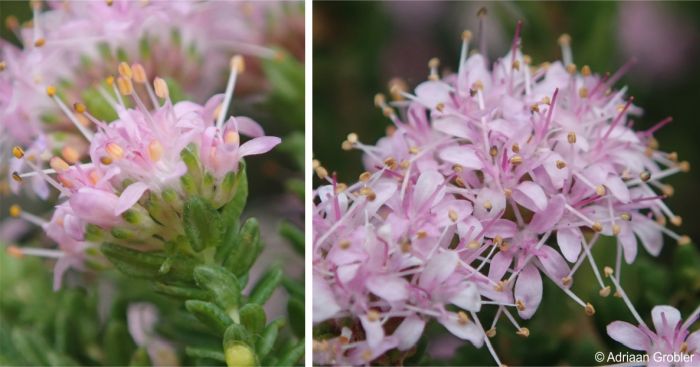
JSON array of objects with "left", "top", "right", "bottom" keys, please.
[{"left": 0, "top": 0, "right": 298, "bottom": 199}]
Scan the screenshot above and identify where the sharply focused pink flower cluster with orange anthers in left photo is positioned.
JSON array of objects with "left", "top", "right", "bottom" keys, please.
[{"left": 11, "top": 56, "right": 280, "bottom": 288}]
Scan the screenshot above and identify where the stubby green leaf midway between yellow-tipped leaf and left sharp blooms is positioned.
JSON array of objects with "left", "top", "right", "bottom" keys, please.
[{"left": 194, "top": 265, "right": 241, "bottom": 313}]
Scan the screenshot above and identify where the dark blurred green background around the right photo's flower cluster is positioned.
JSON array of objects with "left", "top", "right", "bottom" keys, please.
[{"left": 313, "top": 1, "right": 700, "bottom": 365}]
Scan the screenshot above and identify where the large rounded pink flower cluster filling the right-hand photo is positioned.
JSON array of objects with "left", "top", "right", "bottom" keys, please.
[{"left": 313, "top": 23, "right": 690, "bottom": 364}]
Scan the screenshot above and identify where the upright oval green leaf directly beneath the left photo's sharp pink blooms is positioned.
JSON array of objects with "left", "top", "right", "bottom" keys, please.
[{"left": 183, "top": 196, "right": 222, "bottom": 252}]
